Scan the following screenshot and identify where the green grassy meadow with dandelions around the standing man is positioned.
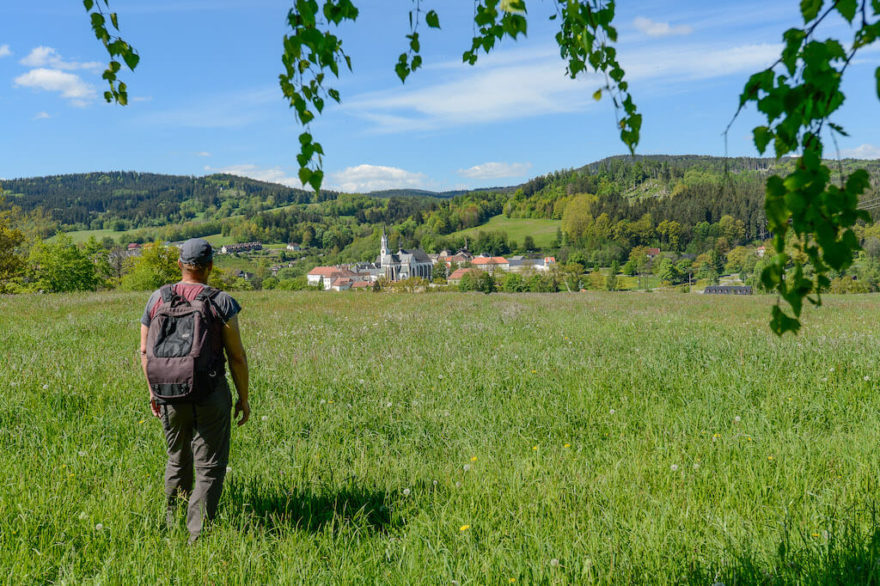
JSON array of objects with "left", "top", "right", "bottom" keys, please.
[{"left": 0, "top": 292, "right": 880, "bottom": 586}]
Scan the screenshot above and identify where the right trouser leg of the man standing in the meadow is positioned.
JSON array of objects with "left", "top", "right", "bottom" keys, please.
[{"left": 186, "top": 380, "right": 232, "bottom": 540}]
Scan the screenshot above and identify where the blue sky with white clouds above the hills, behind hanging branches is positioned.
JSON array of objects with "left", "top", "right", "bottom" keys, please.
[{"left": 0, "top": 0, "right": 880, "bottom": 191}]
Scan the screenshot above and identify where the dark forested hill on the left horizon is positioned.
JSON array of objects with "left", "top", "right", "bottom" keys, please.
[{"left": 0, "top": 171, "right": 324, "bottom": 230}]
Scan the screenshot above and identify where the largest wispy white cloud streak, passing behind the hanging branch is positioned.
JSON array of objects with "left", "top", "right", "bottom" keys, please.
[{"left": 342, "top": 42, "right": 780, "bottom": 133}]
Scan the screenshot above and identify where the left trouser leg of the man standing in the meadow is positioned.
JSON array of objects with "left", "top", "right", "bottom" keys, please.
[{"left": 162, "top": 404, "right": 193, "bottom": 527}]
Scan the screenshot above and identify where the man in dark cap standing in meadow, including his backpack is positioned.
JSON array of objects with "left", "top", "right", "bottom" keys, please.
[{"left": 141, "top": 238, "right": 250, "bottom": 543}]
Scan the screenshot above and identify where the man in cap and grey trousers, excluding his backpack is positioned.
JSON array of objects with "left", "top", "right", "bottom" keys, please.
[{"left": 141, "top": 238, "right": 251, "bottom": 543}]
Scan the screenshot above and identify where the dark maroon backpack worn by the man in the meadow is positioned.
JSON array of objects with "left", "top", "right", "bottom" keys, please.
[{"left": 147, "top": 285, "right": 225, "bottom": 403}]
